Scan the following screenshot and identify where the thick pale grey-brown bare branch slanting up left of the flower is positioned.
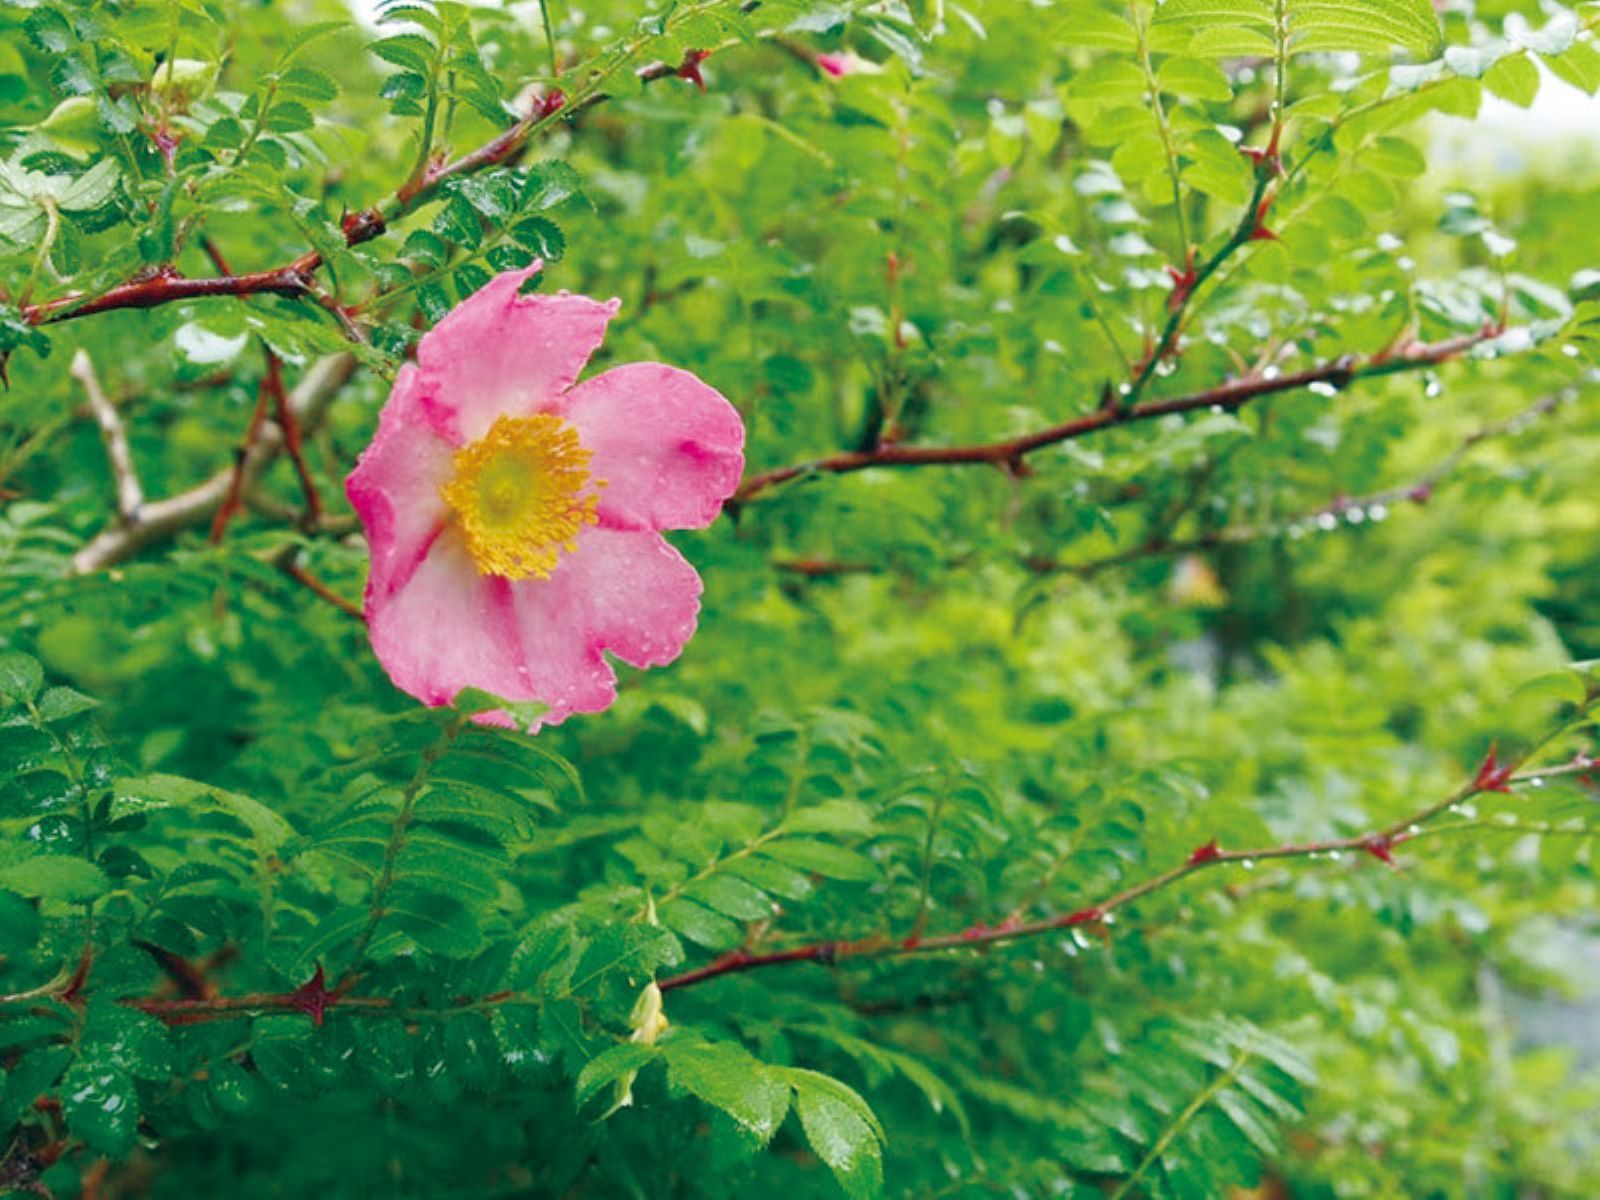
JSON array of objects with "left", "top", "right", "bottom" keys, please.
[{"left": 72, "top": 354, "right": 355, "bottom": 574}]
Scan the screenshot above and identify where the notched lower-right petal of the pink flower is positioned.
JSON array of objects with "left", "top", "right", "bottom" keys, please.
[{"left": 510, "top": 526, "right": 701, "bottom": 725}]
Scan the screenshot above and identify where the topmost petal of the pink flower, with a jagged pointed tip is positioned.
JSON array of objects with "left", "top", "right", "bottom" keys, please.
[{"left": 416, "top": 262, "right": 621, "bottom": 446}]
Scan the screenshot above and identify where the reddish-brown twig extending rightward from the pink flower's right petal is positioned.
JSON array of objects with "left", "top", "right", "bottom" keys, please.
[{"left": 731, "top": 326, "right": 1502, "bottom": 504}]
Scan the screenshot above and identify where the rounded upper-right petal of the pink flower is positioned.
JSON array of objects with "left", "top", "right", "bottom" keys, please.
[{"left": 562, "top": 363, "right": 744, "bottom": 530}]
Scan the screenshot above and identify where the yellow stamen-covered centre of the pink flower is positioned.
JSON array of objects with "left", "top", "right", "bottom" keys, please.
[{"left": 440, "top": 413, "right": 600, "bottom": 579}]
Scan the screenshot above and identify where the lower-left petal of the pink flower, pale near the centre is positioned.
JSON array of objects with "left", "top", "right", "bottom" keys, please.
[{"left": 366, "top": 528, "right": 530, "bottom": 704}]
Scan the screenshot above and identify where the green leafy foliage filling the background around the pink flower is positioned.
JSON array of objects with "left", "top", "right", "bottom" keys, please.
[{"left": 0, "top": 0, "right": 1600, "bottom": 1197}]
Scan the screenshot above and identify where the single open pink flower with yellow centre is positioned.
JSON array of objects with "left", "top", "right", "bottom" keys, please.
[{"left": 346, "top": 262, "right": 744, "bottom": 725}]
